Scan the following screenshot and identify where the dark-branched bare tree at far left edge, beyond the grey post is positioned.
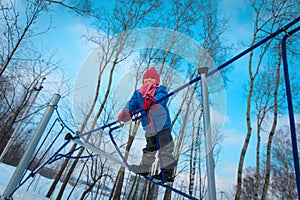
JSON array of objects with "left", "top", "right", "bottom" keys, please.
[{"left": 0, "top": 1, "right": 64, "bottom": 162}]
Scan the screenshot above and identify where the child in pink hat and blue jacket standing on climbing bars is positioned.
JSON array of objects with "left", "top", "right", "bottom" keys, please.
[{"left": 118, "top": 67, "right": 176, "bottom": 182}]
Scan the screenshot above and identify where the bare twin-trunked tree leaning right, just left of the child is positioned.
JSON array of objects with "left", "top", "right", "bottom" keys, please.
[{"left": 47, "top": 1, "right": 164, "bottom": 198}]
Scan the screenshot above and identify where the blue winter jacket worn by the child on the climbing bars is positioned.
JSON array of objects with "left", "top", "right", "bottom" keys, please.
[{"left": 123, "top": 85, "right": 171, "bottom": 133}]
